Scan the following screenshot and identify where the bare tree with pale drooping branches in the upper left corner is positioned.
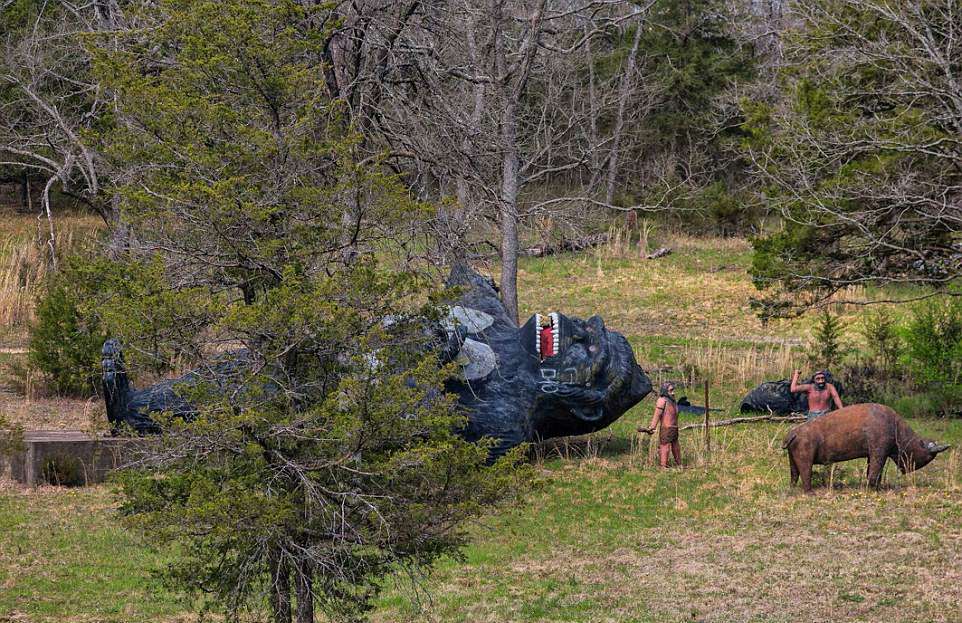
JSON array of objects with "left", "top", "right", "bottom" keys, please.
[{"left": 0, "top": 0, "right": 118, "bottom": 265}]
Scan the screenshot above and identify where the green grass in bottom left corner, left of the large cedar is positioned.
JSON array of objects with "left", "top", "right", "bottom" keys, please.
[{"left": 0, "top": 486, "right": 184, "bottom": 621}]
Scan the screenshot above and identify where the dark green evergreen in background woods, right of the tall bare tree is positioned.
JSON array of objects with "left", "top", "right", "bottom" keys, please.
[{"left": 601, "top": 0, "right": 760, "bottom": 235}]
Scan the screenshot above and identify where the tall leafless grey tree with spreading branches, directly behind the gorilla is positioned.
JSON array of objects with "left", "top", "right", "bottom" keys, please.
[{"left": 344, "top": 0, "right": 660, "bottom": 322}]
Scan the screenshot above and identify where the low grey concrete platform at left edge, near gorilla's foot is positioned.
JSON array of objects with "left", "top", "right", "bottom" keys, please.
[{"left": 0, "top": 430, "right": 143, "bottom": 487}]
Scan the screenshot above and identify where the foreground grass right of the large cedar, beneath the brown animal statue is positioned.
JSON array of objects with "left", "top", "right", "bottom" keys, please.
[{"left": 375, "top": 418, "right": 962, "bottom": 621}]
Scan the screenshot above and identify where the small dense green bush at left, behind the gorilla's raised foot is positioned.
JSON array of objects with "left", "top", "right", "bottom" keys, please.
[{"left": 29, "top": 260, "right": 106, "bottom": 396}]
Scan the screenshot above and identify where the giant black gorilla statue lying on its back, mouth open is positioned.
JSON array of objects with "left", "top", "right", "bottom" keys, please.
[{"left": 102, "top": 266, "right": 651, "bottom": 456}]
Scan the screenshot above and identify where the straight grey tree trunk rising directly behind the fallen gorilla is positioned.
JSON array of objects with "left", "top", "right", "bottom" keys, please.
[{"left": 501, "top": 102, "right": 519, "bottom": 322}]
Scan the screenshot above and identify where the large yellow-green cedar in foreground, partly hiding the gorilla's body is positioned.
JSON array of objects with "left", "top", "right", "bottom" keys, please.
[{"left": 93, "top": 0, "right": 520, "bottom": 620}]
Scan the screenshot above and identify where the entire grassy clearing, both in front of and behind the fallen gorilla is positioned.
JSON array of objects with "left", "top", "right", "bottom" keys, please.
[{"left": 0, "top": 232, "right": 962, "bottom": 623}]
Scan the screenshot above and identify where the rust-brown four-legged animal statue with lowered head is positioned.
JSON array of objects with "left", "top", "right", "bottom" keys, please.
[{"left": 782, "top": 404, "right": 949, "bottom": 492}]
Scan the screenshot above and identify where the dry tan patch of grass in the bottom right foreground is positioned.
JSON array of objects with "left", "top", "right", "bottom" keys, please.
[{"left": 502, "top": 502, "right": 962, "bottom": 623}]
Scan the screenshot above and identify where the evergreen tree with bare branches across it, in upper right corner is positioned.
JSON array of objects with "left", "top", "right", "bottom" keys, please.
[{"left": 742, "top": 0, "right": 962, "bottom": 316}]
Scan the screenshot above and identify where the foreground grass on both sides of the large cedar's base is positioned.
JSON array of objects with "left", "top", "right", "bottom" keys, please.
[{"left": 0, "top": 409, "right": 962, "bottom": 622}]
